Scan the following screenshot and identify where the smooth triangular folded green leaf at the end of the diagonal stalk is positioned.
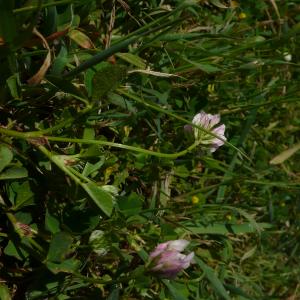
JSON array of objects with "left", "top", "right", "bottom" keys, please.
[{"left": 81, "top": 182, "right": 113, "bottom": 217}]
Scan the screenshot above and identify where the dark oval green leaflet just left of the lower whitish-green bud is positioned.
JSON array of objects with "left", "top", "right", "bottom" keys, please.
[{"left": 47, "top": 231, "right": 73, "bottom": 263}]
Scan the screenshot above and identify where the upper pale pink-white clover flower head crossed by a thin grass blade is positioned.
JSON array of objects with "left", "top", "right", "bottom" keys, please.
[{"left": 192, "top": 111, "right": 226, "bottom": 152}]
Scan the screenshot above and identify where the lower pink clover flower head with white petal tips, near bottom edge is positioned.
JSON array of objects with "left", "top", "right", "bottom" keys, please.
[{"left": 149, "top": 240, "right": 194, "bottom": 279}]
